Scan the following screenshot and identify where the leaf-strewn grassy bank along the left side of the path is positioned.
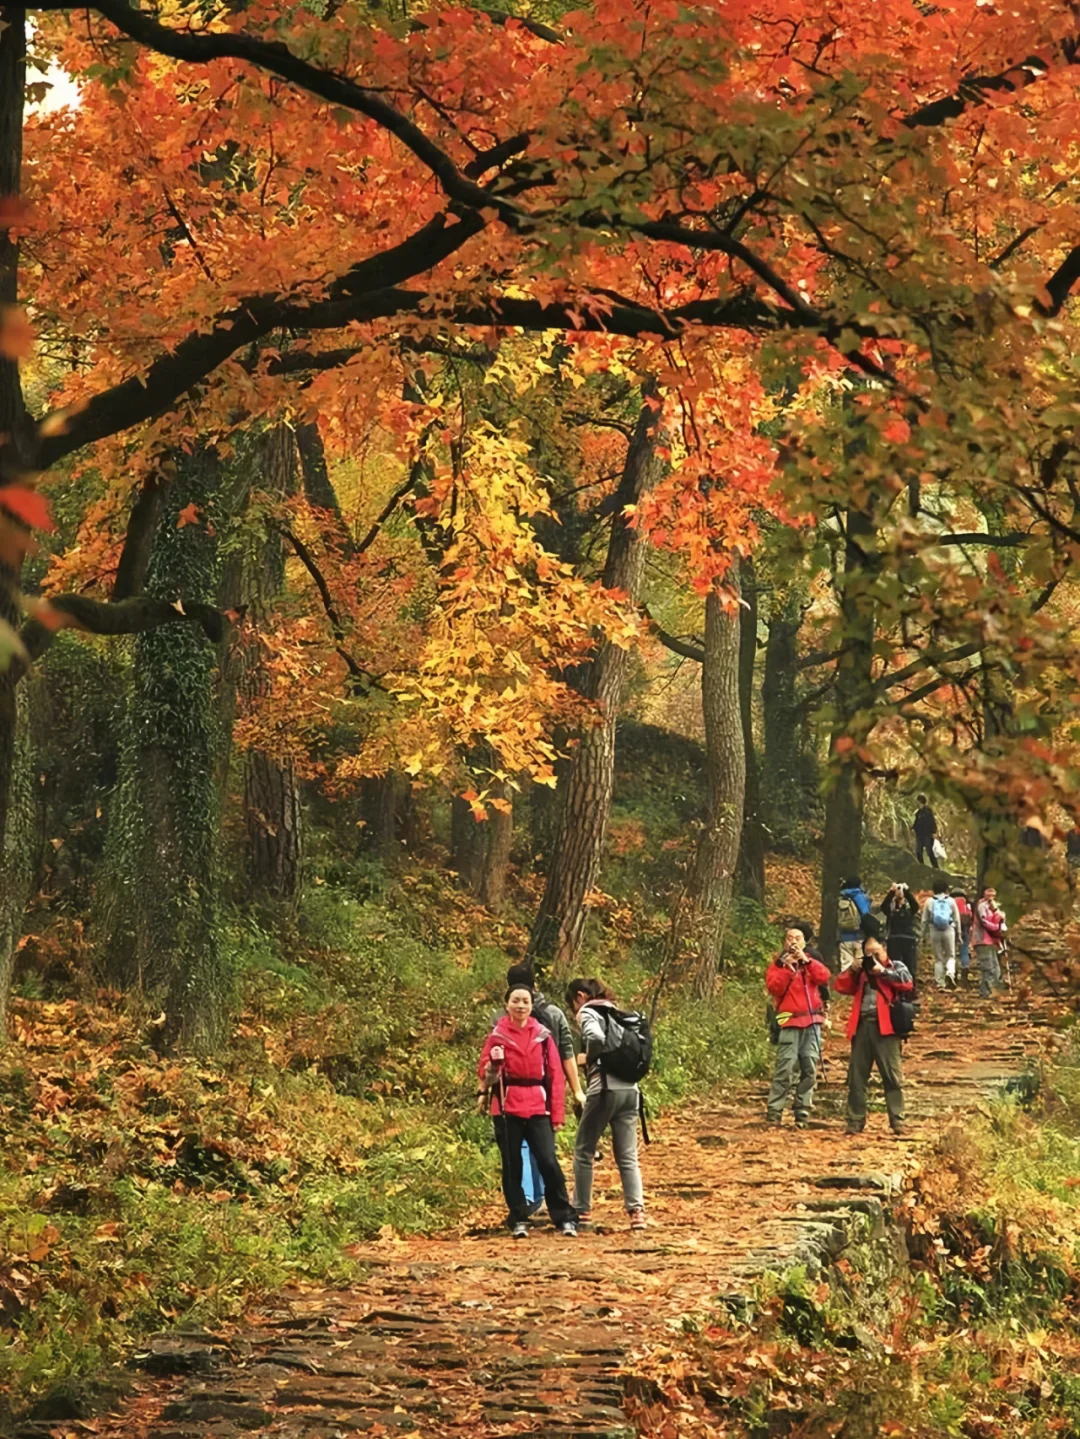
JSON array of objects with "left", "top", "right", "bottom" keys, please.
[{"left": 0, "top": 856, "right": 774, "bottom": 1417}]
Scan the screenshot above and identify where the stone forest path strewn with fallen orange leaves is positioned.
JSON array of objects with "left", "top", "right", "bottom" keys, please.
[{"left": 74, "top": 984, "right": 1045, "bottom": 1439}]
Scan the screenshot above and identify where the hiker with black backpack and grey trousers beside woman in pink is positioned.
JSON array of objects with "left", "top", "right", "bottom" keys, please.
[{"left": 567, "top": 979, "right": 653, "bottom": 1230}]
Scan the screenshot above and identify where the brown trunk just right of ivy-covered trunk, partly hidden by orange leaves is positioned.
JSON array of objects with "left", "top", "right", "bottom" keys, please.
[{"left": 240, "top": 425, "right": 303, "bottom": 907}]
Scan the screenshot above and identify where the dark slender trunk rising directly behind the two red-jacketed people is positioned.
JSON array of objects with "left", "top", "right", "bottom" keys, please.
[{"left": 820, "top": 509, "right": 879, "bottom": 961}]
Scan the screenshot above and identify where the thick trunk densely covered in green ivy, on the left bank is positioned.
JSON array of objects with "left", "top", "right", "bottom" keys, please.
[{"left": 105, "top": 449, "right": 229, "bottom": 1050}]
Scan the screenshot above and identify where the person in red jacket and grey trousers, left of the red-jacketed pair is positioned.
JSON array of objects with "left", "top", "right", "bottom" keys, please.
[{"left": 765, "top": 930, "right": 831, "bottom": 1130}]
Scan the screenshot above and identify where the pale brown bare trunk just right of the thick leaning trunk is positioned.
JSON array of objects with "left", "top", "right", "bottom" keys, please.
[{"left": 687, "top": 591, "right": 746, "bottom": 996}]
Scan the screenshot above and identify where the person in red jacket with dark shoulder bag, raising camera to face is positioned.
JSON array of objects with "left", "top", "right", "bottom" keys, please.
[{"left": 837, "top": 940, "right": 915, "bottom": 1134}]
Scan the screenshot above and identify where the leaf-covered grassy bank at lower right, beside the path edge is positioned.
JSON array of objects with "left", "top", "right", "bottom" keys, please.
[{"left": 633, "top": 1063, "right": 1080, "bottom": 1439}]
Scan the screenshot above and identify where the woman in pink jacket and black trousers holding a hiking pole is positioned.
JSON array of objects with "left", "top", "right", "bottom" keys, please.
[{"left": 477, "top": 984, "right": 578, "bottom": 1239}]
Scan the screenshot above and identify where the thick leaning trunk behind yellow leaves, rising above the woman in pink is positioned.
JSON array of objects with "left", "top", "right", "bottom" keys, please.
[{"left": 528, "top": 389, "right": 660, "bottom": 968}]
